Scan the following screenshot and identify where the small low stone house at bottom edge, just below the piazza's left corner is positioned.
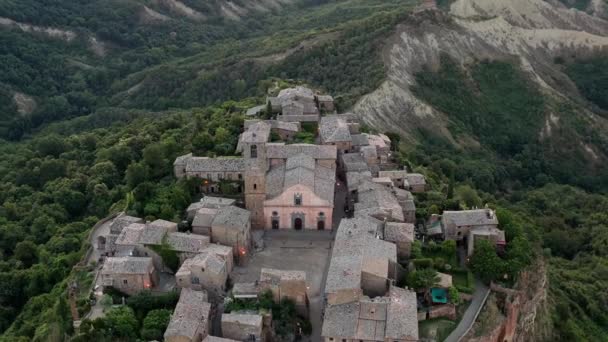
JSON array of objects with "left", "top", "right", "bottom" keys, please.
[{"left": 222, "top": 313, "right": 266, "bottom": 342}]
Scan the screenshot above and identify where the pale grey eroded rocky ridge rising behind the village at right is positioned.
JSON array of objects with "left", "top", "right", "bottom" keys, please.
[{"left": 354, "top": 0, "right": 608, "bottom": 148}]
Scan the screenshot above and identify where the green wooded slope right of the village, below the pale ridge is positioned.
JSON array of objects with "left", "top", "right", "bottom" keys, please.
[{"left": 410, "top": 56, "right": 608, "bottom": 341}]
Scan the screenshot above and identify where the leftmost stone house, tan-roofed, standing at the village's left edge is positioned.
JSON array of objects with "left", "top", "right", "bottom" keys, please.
[{"left": 100, "top": 257, "right": 159, "bottom": 295}]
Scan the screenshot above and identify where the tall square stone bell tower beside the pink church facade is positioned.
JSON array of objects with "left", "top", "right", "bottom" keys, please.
[{"left": 240, "top": 122, "right": 270, "bottom": 229}]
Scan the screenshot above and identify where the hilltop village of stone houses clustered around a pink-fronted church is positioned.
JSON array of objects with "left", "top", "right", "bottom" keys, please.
[{"left": 82, "top": 86, "right": 505, "bottom": 341}]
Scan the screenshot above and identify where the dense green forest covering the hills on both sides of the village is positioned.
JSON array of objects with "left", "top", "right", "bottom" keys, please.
[{"left": 0, "top": 0, "right": 608, "bottom": 341}]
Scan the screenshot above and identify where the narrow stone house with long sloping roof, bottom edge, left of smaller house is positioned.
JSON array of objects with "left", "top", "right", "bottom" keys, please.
[{"left": 164, "top": 288, "right": 212, "bottom": 342}]
